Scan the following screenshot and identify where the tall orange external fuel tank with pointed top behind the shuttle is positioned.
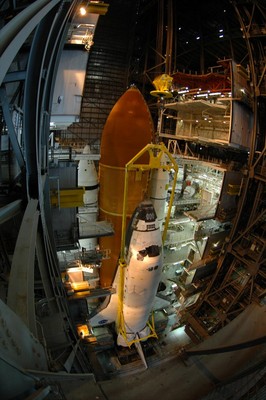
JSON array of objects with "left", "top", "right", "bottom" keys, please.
[{"left": 99, "top": 87, "right": 154, "bottom": 287}]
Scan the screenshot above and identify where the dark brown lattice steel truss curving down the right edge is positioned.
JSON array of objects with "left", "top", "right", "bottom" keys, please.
[{"left": 186, "top": 1, "right": 266, "bottom": 341}]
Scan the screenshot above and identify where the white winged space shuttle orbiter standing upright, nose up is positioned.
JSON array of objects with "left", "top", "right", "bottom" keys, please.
[{"left": 89, "top": 200, "right": 163, "bottom": 346}]
